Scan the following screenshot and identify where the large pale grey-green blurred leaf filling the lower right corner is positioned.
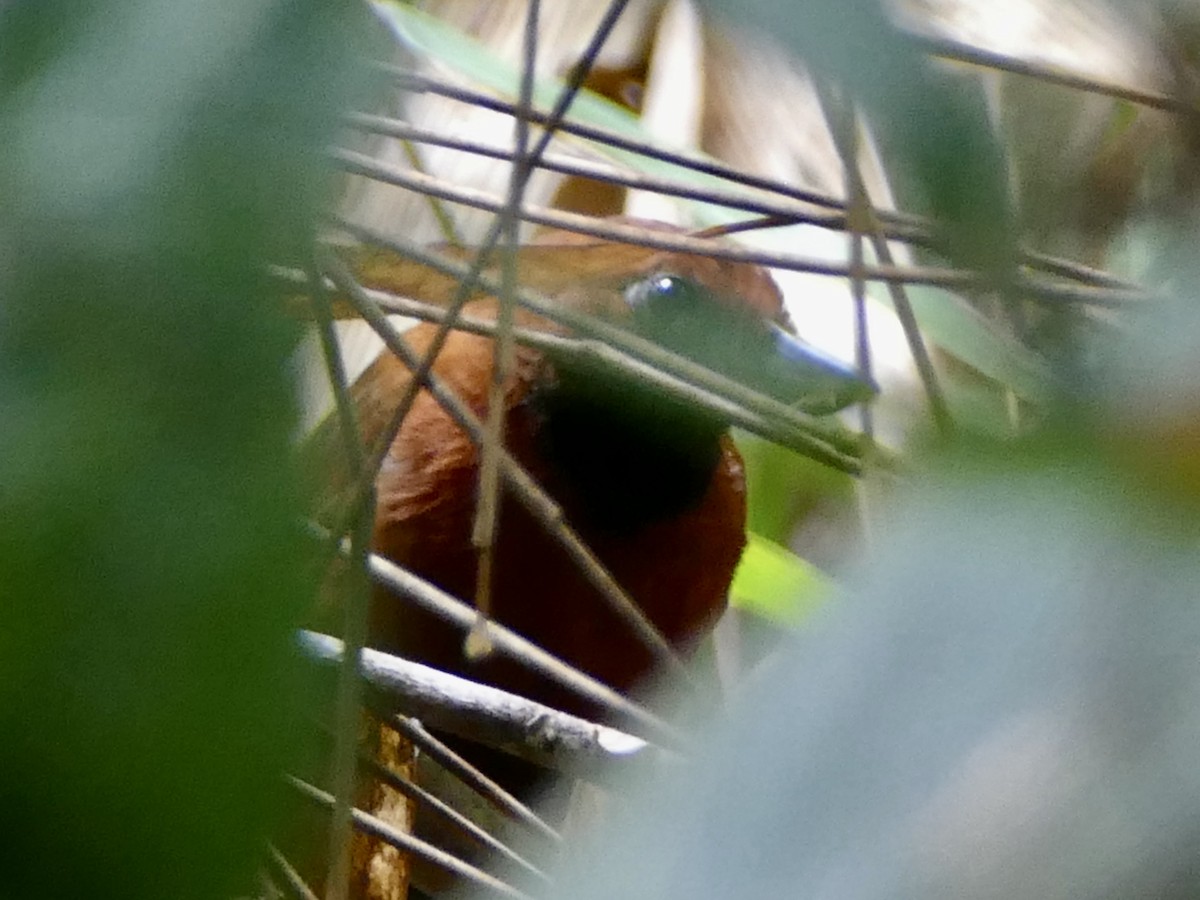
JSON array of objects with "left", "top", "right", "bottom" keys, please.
[{"left": 549, "top": 445, "right": 1200, "bottom": 900}]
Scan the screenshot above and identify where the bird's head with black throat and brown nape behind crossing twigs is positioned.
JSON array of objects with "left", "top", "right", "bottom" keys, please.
[{"left": 338, "top": 220, "right": 876, "bottom": 530}]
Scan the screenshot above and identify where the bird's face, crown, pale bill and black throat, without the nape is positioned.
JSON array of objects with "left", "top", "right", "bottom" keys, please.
[{"left": 501, "top": 223, "right": 876, "bottom": 532}]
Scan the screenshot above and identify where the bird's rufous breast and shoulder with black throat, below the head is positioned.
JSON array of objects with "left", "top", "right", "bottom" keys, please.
[{"left": 360, "top": 326, "right": 745, "bottom": 714}]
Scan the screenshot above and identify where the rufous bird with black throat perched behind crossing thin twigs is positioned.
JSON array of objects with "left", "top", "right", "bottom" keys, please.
[{"left": 328, "top": 222, "right": 874, "bottom": 715}]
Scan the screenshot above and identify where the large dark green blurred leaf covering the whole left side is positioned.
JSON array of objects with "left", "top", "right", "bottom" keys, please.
[{"left": 0, "top": 0, "right": 364, "bottom": 898}]
